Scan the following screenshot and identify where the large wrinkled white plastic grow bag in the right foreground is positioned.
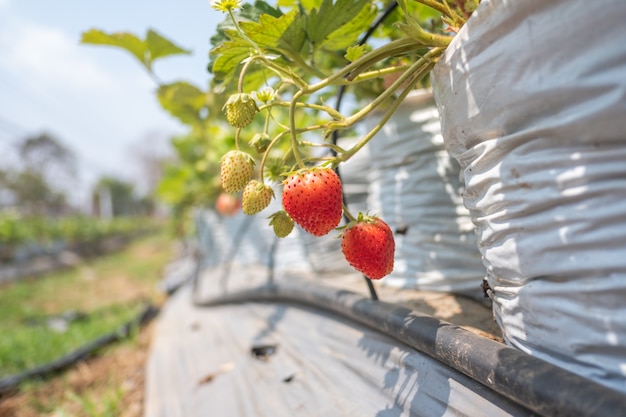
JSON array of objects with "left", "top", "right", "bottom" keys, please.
[{"left": 433, "top": 0, "right": 626, "bottom": 392}]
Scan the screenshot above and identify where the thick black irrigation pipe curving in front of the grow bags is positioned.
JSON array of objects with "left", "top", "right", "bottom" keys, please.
[{"left": 196, "top": 283, "right": 626, "bottom": 417}]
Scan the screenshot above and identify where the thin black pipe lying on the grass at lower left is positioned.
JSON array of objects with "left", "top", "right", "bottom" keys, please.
[{"left": 0, "top": 304, "right": 158, "bottom": 394}]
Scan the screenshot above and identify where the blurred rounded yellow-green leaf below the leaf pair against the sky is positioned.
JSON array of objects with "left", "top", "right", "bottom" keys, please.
[{"left": 157, "top": 81, "right": 206, "bottom": 125}]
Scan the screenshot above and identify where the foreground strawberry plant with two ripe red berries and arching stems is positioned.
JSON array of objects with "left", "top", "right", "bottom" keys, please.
[{"left": 210, "top": 0, "right": 477, "bottom": 279}]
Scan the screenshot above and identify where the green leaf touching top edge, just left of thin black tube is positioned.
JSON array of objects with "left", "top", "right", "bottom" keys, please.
[{"left": 308, "top": 0, "right": 372, "bottom": 46}]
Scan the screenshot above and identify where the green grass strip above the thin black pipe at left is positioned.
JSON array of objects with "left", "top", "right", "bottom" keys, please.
[{"left": 0, "top": 226, "right": 171, "bottom": 378}]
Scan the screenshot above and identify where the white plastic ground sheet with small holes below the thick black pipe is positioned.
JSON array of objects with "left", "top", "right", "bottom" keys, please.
[{"left": 145, "top": 272, "right": 535, "bottom": 417}]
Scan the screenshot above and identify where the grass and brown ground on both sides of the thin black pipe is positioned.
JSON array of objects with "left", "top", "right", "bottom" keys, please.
[{"left": 0, "top": 228, "right": 173, "bottom": 417}]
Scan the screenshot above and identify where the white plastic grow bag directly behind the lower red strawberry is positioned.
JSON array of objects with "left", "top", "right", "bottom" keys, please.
[{"left": 365, "top": 90, "right": 485, "bottom": 298}]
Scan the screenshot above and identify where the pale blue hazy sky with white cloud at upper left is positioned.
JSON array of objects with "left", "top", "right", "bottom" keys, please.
[{"left": 0, "top": 0, "right": 223, "bottom": 206}]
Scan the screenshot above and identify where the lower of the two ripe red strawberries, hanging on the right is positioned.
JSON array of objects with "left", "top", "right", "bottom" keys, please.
[{"left": 341, "top": 213, "right": 396, "bottom": 279}]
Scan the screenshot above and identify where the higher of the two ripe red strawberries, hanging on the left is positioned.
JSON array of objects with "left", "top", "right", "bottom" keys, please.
[{"left": 283, "top": 168, "right": 343, "bottom": 236}]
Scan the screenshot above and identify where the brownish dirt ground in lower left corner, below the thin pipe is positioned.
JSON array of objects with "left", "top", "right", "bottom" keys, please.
[{"left": 0, "top": 324, "right": 153, "bottom": 417}]
